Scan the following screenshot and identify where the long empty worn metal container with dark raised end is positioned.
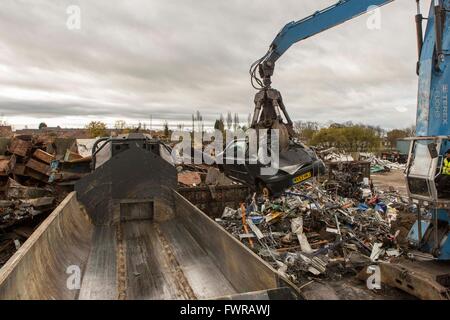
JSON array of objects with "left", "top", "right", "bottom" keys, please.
[{"left": 0, "top": 136, "right": 299, "bottom": 299}]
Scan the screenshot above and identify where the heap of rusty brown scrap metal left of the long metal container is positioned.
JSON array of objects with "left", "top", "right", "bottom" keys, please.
[{"left": 0, "top": 136, "right": 90, "bottom": 266}]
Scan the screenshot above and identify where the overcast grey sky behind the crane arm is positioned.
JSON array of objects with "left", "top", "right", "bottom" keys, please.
[{"left": 0, "top": 0, "right": 429, "bottom": 128}]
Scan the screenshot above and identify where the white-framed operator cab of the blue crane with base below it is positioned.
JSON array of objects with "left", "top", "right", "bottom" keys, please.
[{"left": 406, "top": 136, "right": 450, "bottom": 260}]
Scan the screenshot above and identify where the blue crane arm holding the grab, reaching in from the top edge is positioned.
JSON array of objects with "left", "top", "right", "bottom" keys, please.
[{"left": 252, "top": 0, "right": 394, "bottom": 86}]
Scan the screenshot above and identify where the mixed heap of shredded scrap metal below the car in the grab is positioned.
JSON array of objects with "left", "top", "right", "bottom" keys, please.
[{"left": 216, "top": 183, "right": 408, "bottom": 285}]
